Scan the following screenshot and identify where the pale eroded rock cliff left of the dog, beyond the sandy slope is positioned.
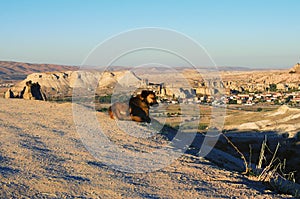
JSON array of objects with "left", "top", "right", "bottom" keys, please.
[{"left": 5, "top": 70, "right": 142, "bottom": 99}]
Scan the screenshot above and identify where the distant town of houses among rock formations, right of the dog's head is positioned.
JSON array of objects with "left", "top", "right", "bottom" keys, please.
[{"left": 132, "top": 79, "right": 300, "bottom": 106}]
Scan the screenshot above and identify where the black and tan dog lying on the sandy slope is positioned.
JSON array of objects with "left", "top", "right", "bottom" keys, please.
[{"left": 108, "top": 90, "right": 158, "bottom": 123}]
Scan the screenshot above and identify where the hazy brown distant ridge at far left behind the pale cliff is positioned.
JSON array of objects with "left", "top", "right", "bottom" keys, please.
[{"left": 0, "top": 61, "right": 78, "bottom": 81}]
